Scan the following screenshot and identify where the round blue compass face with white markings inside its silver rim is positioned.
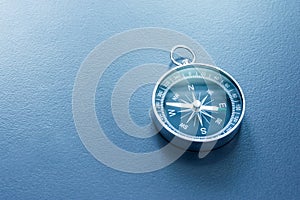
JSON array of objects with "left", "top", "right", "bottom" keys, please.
[{"left": 152, "top": 63, "right": 244, "bottom": 142}]
